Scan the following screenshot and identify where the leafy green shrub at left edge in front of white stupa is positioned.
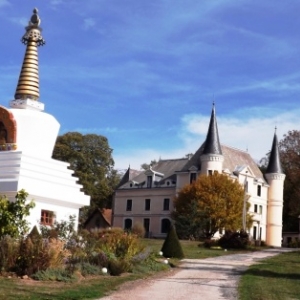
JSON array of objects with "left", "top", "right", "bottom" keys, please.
[{"left": 0, "top": 190, "right": 35, "bottom": 238}]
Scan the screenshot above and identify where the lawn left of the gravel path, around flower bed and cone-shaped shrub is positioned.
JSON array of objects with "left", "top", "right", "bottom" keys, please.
[{"left": 0, "top": 239, "right": 260, "bottom": 300}]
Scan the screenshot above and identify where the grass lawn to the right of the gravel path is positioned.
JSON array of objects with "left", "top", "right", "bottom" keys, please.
[{"left": 239, "top": 251, "right": 300, "bottom": 300}]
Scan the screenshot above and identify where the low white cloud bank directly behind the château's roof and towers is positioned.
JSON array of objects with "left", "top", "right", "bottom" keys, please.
[{"left": 114, "top": 108, "right": 300, "bottom": 169}]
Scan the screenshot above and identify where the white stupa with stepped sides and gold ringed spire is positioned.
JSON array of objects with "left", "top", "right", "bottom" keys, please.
[{"left": 0, "top": 9, "right": 90, "bottom": 227}]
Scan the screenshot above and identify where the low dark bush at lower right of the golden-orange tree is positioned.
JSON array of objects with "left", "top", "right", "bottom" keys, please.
[{"left": 218, "top": 231, "right": 250, "bottom": 249}]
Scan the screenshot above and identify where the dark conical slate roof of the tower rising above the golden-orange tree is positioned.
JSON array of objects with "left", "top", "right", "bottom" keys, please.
[{"left": 203, "top": 104, "right": 222, "bottom": 155}]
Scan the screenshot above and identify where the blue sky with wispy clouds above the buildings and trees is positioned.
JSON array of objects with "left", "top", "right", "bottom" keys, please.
[{"left": 0, "top": 0, "right": 300, "bottom": 169}]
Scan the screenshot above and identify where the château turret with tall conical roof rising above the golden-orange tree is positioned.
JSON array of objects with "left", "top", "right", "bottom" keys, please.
[{"left": 200, "top": 103, "right": 224, "bottom": 174}]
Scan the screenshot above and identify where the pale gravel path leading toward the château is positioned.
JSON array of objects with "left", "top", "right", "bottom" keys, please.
[{"left": 101, "top": 248, "right": 291, "bottom": 300}]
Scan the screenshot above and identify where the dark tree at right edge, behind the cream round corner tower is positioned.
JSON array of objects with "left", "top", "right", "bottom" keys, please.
[{"left": 279, "top": 130, "right": 300, "bottom": 231}]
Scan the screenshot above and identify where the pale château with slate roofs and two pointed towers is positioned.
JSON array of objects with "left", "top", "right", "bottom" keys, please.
[{"left": 113, "top": 105, "right": 285, "bottom": 246}]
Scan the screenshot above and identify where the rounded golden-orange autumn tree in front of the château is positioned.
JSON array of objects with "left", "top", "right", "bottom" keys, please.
[{"left": 173, "top": 173, "right": 249, "bottom": 238}]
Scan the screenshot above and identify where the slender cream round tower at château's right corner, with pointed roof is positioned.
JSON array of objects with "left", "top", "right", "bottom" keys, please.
[{"left": 265, "top": 129, "right": 285, "bottom": 247}]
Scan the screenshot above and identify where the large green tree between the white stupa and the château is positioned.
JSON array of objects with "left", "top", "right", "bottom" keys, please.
[{"left": 53, "top": 132, "right": 120, "bottom": 211}]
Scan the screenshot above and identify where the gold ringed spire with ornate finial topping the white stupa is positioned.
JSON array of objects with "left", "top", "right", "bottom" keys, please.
[{"left": 15, "top": 8, "right": 45, "bottom": 100}]
